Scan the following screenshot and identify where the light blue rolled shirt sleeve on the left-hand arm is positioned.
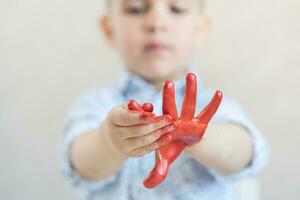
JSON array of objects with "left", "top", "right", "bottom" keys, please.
[{"left": 59, "top": 88, "right": 120, "bottom": 191}]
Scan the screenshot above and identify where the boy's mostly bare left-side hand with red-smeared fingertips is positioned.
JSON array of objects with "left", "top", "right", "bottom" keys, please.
[{"left": 105, "top": 101, "right": 176, "bottom": 158}]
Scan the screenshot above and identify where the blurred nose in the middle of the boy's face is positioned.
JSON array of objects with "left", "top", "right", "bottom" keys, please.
[{"left": 145, "top": 1, "right": 169, "bottom": 32}]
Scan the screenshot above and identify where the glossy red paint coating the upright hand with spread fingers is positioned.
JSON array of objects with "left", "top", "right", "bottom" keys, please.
[{"left": 129, "top": 73, "right": 222, "bottom": 188}]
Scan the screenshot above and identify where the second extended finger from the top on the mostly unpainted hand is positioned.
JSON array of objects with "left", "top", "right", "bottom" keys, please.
[{"left": 126, "top": 115, "right": 176, "bottom": 138}]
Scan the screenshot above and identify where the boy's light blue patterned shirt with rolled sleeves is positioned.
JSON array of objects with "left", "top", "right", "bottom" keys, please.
[{"left": 60, "top": 69, "right": 269, "bottom": 200}]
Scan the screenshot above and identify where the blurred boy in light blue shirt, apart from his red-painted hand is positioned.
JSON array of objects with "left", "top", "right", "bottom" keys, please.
[{"left": 62, "top": 0, "right": 268, "bottom": 200}]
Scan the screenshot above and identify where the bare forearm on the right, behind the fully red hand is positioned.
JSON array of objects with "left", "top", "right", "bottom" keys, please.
[{"left": 186, "top": 123, "right": 253, "bottom": 174}]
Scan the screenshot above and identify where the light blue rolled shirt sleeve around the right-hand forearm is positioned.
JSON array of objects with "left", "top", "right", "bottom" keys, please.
[{"left": 202, "top": 89, "right": 270, "bottom": 181}]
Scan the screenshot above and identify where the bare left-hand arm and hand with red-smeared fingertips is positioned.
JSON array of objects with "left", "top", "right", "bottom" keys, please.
[{"left": 70, "top": 105, "right": 174, "bottom": 180}]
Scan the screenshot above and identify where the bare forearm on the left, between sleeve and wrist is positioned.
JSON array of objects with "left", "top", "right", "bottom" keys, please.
[{"left": 70, "top": 121, "right": 126, "bottom": 180}]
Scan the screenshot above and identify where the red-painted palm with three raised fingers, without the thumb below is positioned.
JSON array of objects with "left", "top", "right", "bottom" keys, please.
[{"left": 162, "top": 73, "right": 222, "bottom": 146}]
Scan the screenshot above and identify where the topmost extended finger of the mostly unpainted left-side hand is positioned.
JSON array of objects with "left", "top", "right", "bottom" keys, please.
[{"left": 110, "top": 105, "right": 159, "bottom": 126}]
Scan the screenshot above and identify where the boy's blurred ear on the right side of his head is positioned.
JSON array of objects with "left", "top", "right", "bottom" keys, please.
[{"left": 196, "top": 15, "right": 211, "bottom": 47}]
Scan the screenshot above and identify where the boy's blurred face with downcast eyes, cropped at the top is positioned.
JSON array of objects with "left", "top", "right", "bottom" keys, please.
[{"left": 102, "top": 0, "right": 207, "bottom": 82}]
